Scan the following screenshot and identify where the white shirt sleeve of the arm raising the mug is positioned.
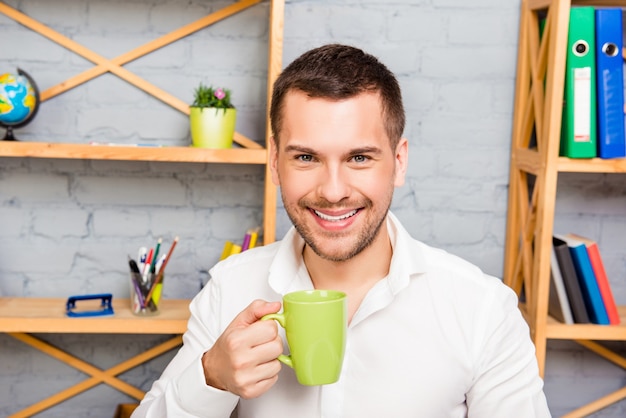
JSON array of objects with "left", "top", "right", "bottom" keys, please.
[{"left": 132, "top": 280, "right": 239, "bottom": 418}]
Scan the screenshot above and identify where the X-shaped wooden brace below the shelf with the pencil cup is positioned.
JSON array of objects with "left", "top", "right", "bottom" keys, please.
[{"left": 8, "top": 332, "right": 183, "bottom": 418}]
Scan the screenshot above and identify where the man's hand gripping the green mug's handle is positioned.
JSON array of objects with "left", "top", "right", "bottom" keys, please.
[{"left": 202, "top": 300, "right": 283, "bottom": 399}]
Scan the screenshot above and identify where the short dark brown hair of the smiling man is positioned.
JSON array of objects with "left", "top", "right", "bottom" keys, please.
[{"left": 270, "top": 44, "right": 405, "bottom": 149}]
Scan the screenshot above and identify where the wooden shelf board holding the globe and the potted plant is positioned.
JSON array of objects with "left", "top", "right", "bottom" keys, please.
[{"left": 0, "top": 141, "right": 267, "bottom": 164}]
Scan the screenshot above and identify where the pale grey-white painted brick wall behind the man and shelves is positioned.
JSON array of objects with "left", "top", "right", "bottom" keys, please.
[{"left": 0, "top": 0, "right": 626, "bottom": 417}]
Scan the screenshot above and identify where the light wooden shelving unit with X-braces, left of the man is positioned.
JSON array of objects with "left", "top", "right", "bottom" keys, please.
[{"left": 0, "top": 0, "right": 285, "bottom": 418}]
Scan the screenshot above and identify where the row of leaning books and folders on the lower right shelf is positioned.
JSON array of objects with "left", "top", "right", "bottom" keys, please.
[{"left": 548, "top": 234, "right": 620, "bottom": 325}]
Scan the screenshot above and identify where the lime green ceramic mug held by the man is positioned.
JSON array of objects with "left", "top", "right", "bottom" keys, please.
[{"left": 262, "top": 290, "right": 348, "bottom": 386}]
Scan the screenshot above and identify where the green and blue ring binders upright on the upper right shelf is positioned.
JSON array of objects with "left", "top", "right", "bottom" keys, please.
[{"left": 559, "top": 7, "right": 626, "bottom": 158}]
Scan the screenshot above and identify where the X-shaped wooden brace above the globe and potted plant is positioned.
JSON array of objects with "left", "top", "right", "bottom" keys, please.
[{"left": 0, "top": 0, "right": 262, "bottom": 148}]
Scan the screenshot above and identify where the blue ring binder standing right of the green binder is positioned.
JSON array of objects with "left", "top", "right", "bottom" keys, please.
[{"left": 595, "top": 7, "right": 626, "bottom": 158}]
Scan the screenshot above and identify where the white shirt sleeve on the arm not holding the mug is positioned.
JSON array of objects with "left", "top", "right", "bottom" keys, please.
[{"left": 466, "top": 283, "right": 551, "bottom": 418}]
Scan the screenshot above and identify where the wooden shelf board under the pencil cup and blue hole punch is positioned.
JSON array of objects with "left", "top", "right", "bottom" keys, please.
[{"left": 0, "top": 297, "right": 189, "bottom": 334}]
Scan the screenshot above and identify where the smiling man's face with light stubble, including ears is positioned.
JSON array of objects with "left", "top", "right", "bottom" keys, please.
[{"left": 271, "top": 91, "right": 407, "bottom": 261}]
